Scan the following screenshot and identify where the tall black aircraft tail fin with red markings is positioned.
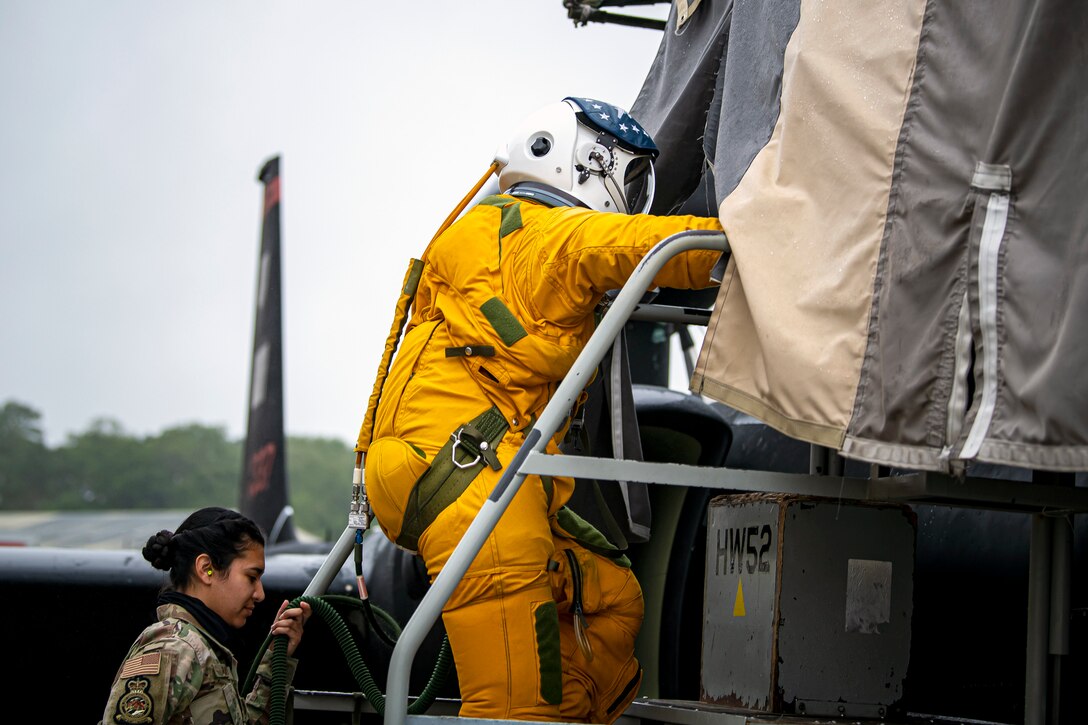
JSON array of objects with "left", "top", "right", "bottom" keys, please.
[{"left": 240, "top": 157, "right": 296, "bottom": 545}]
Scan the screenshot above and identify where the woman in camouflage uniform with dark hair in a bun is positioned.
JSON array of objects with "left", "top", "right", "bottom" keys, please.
[{"left": 101, "top": 507, "right": 310, "bottom": 725}]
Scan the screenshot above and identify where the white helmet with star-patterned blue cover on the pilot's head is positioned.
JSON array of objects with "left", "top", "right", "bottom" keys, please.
[{"left": 496, "top": 97, "right": 658, "bottom": 214}]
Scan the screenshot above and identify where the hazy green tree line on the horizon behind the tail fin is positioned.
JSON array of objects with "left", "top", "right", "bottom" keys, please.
[{"left": 0, "top": 401, "right": 355, "bottom": 539}]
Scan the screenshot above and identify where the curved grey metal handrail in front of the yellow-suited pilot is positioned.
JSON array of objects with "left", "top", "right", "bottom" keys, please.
[{"left": 384, "top": 230, "right": 729, "bottom": 725}]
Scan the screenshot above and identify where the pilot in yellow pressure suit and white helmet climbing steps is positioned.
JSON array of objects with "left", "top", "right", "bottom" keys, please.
[{"left": 357, "top": 98, "right": 721, "bottom": 723}]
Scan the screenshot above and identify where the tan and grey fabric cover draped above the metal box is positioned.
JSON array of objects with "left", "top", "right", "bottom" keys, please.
[{"left": 632, "top": 0, "right": 1088, "bottom": 470}]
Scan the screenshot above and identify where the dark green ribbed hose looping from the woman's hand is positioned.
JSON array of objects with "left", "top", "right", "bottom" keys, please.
[{"left": 243, "top": 594, "right": 453, "bottom": 725}]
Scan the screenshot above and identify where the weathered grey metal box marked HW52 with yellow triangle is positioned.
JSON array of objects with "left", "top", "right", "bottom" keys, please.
[{"left": 701, "top": 493, "right": 917, "bottom": 717}]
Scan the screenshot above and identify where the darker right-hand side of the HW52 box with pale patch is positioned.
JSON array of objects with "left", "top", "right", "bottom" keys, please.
[{"left": 777, "top": 500, "right": 916, "bottom": 717}]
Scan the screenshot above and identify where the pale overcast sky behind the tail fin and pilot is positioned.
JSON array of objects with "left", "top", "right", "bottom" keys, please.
[{"left": 0, "top": 0, "right": 668, "bottom": 445}]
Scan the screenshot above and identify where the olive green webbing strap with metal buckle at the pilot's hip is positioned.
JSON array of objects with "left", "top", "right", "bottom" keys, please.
[{"left": 397, "top": 407, "right": 509, "bottom": 551}]
